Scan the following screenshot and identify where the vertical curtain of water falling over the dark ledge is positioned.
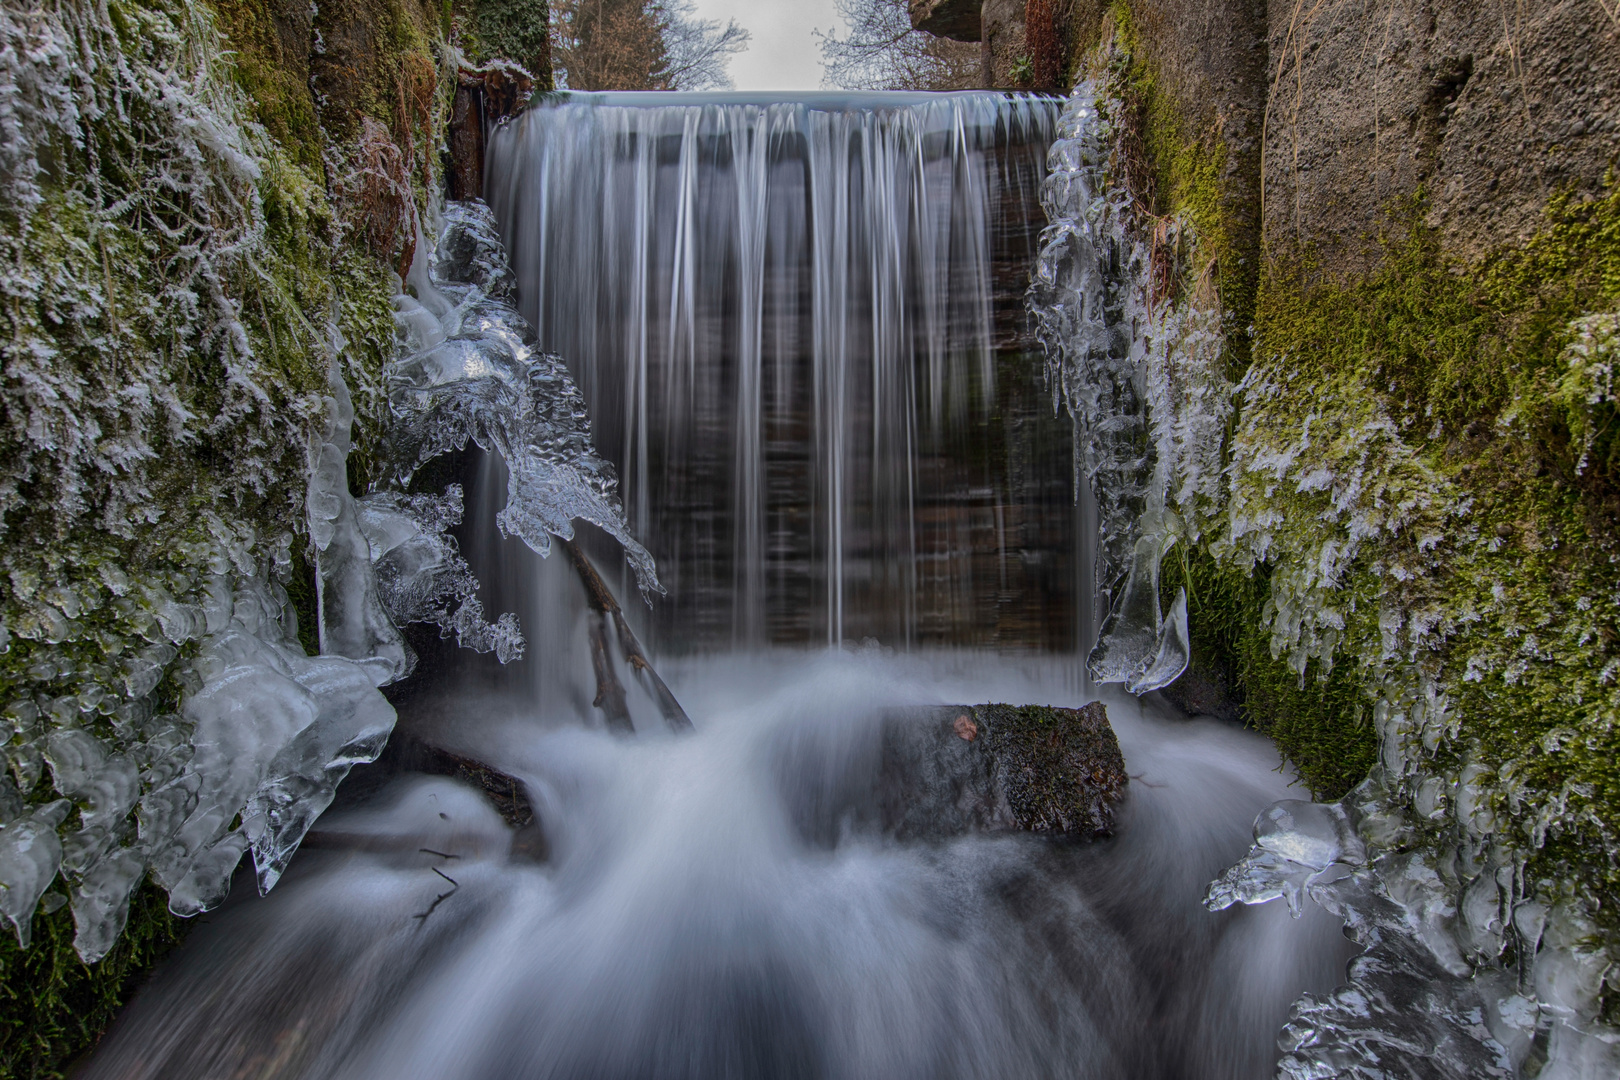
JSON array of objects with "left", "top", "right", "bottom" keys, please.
[{"left": 488, "top": 92, "right": 1090, "bottom": 649}]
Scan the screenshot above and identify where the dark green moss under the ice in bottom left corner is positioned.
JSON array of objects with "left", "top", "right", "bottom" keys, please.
[{"left": 0, "top": 886, "right": 188, "bottom": 1080}]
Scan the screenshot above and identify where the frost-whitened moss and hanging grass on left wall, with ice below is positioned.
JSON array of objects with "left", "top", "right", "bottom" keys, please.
[{"left": 0, "top": 0, "right": 367, "bottom": 960}]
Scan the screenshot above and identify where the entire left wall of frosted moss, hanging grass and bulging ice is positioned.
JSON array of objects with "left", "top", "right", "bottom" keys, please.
[{"left": 0, "top": 0, "right": 557, "bottom": 997}]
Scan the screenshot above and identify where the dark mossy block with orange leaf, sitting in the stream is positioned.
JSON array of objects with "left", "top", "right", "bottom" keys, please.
[{"left": 878, "top": 701, "right": 1126, "bottom": 840}]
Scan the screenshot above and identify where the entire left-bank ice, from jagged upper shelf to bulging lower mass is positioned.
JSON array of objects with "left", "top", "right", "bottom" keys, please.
[{"left": 0, "top": 162, "right": 658, "bottom": 960}]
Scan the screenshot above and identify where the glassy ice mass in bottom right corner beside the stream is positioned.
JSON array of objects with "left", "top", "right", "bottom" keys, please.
[{"left": 1205, "top": 779, "right": 1620, "bottom": 1080}]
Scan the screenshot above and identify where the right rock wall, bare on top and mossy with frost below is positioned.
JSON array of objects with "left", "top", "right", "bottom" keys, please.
[{"left": 1023, "top": 0, "right": 1620, "bottom": 971}]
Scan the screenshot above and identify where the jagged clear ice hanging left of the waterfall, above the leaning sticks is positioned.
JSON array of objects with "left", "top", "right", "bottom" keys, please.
[{"left": 387, "top": 199, "right": 663, "bottom": 595}]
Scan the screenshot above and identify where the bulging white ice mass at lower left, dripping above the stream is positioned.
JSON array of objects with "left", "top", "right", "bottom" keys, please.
[{"left": 0, "top": 542, "right": 394, "bottom": 962}]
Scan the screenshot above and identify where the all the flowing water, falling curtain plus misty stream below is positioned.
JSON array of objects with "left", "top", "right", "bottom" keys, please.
[{"left": 81, "top": 94, "right": 1349, "bottom": 1080}]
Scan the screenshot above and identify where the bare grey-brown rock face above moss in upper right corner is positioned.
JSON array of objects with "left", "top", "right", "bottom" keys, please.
[{"left": 1264, "top": 0, "right": 1620, "bottom": 262}]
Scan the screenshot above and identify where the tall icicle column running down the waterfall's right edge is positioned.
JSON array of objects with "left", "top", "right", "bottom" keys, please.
[{"left": 1029, "top": 84, "right": 1231, "bottom": 693}]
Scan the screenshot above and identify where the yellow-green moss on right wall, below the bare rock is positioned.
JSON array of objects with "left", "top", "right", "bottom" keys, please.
[{"left": 1246, "top": 183, "right": 1620, "bottom": 933}]
